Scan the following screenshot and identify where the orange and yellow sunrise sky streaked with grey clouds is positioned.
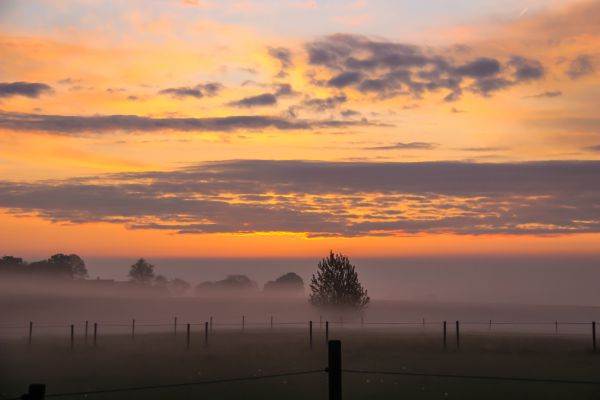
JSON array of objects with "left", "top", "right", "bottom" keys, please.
[{"left": 0, "top": 0, "right": 600, "bottom": 258}]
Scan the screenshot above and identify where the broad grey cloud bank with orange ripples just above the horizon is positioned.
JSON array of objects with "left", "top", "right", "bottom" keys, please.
[{"left": 0, "top": 160, "right": 600, "bottom": 237}]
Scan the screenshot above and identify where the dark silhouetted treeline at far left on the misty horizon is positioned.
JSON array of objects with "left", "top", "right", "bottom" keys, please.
[{"left": 0, "top": 253, "right": 88, "bottom": 279}]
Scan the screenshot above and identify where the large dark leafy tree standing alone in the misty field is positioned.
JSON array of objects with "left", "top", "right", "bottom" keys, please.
[{"left": 310, "top": 251, "right": 370, "bottom": 309}]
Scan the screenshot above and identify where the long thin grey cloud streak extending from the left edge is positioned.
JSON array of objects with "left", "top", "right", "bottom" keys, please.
[{"left": 0, "top": 111, "right": 371, "bottom": 135}]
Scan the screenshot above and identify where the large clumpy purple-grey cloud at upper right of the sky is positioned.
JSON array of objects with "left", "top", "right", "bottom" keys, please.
[{"left": 306, "top": 34, "right": 545, "bottom": 101}]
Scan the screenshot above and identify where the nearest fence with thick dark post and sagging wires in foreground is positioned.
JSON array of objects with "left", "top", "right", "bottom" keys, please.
[{"left": 11, "top": 340, "right": 600, "bottom": 400}]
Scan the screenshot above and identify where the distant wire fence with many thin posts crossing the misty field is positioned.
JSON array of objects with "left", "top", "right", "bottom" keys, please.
[{"left": 0, "top": 316, "right": 597, "bottom": 351}]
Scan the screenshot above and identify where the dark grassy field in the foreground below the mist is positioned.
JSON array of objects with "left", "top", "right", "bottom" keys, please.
[{"left": 0, "top": 328, "right": 600, "bottom": 400}]
